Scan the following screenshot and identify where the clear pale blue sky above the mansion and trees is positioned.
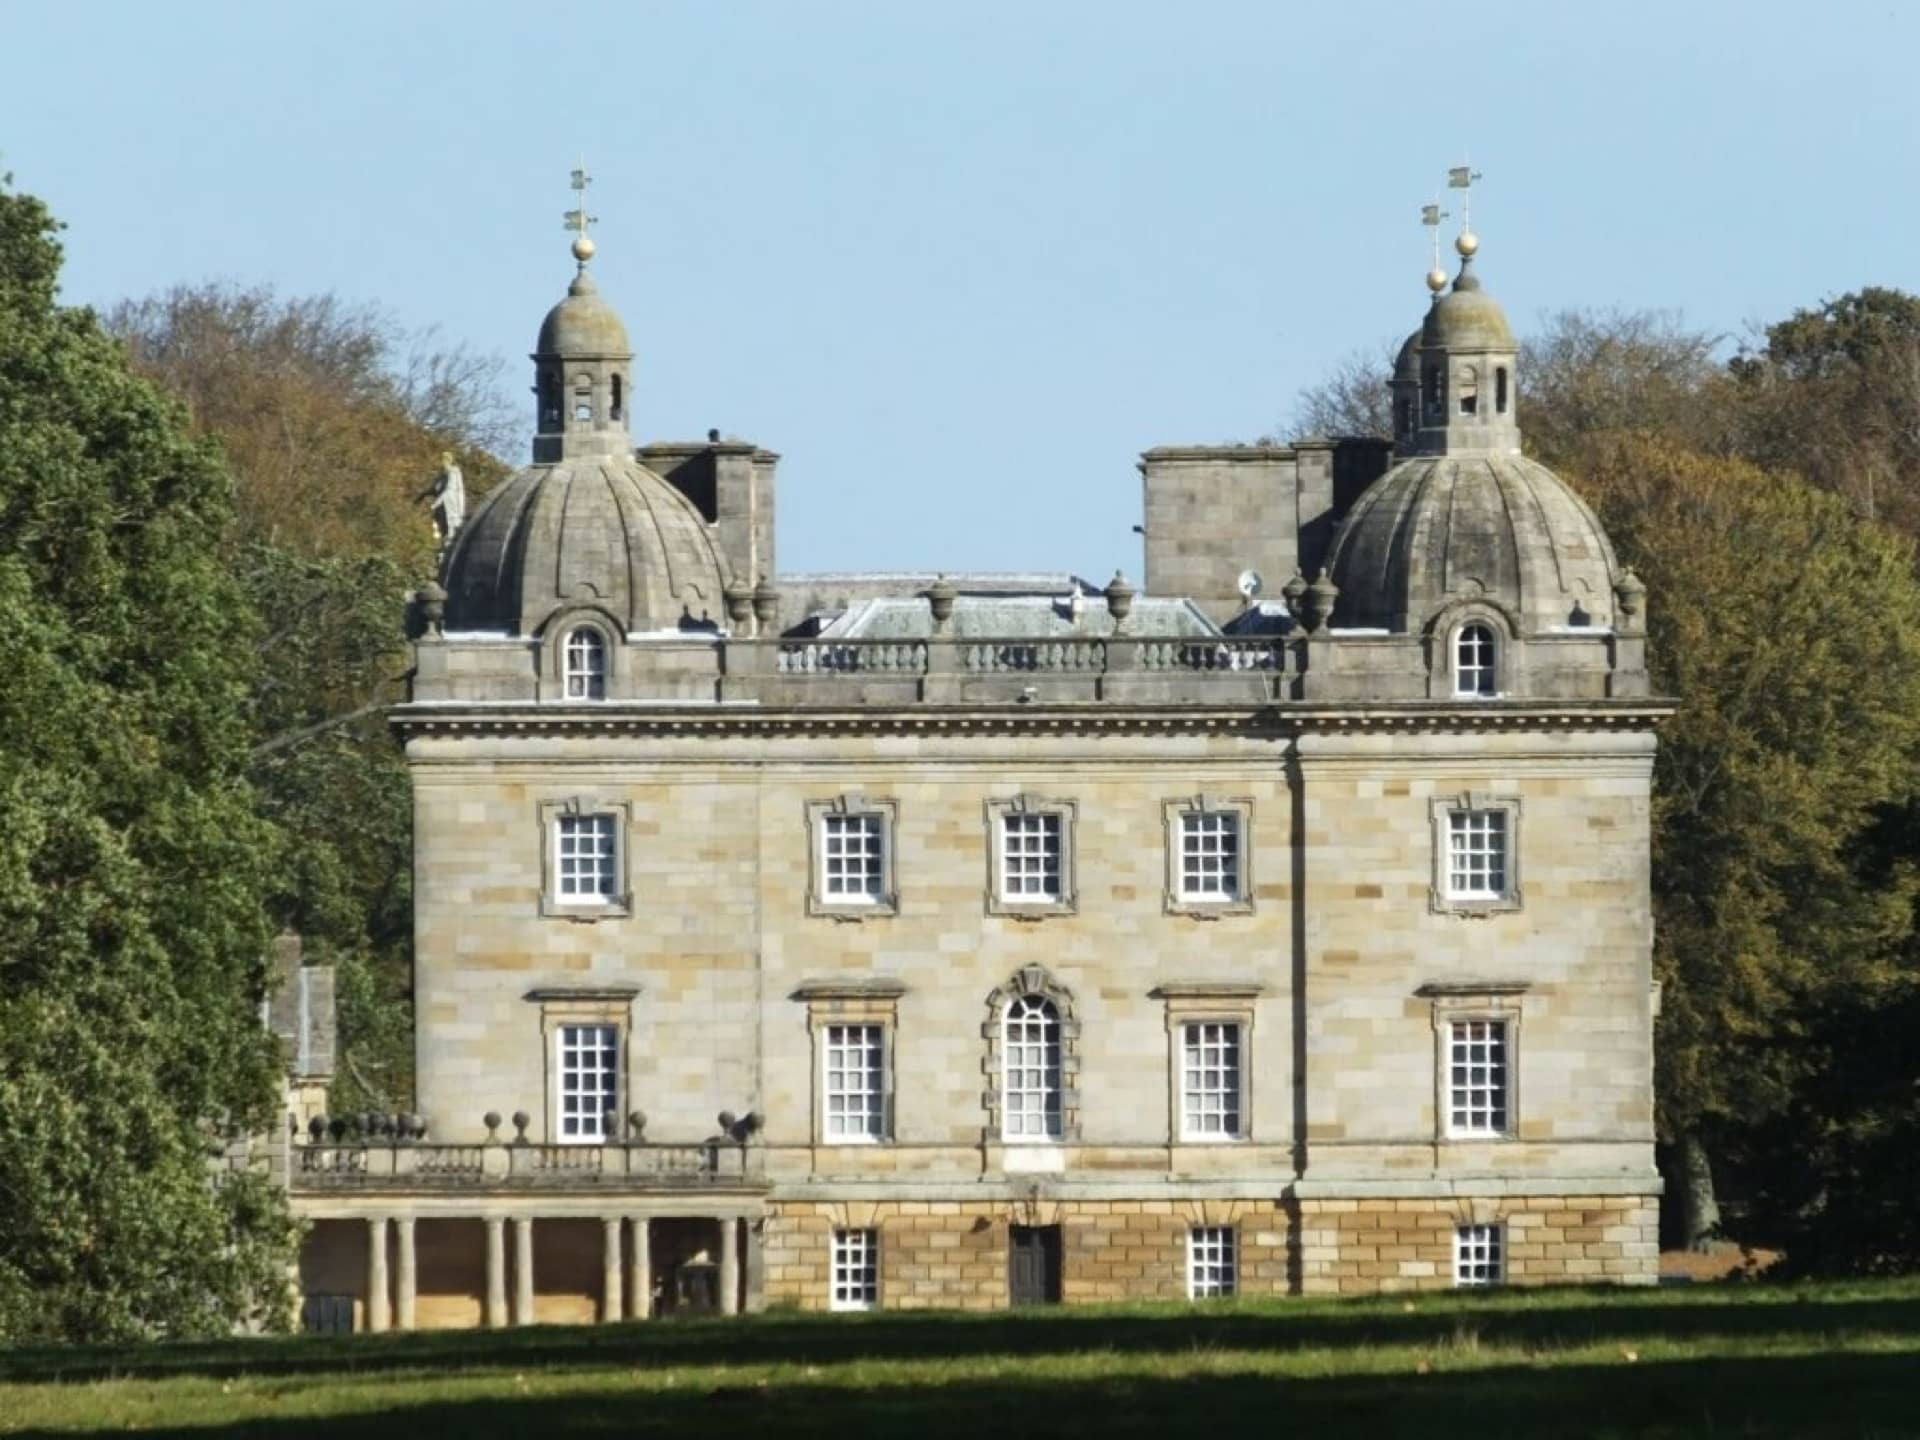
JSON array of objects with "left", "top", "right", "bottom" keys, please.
[{"left": 0, "top": 0, "right": 1920, "bottom": 578}]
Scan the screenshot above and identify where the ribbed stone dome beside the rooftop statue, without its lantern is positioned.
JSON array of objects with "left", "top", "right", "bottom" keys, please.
[{"left": 442, "top": 453, "right": 728, "bottom": 636}]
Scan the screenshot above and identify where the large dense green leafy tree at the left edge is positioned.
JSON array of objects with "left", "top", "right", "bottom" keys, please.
[{"left": 0, "top": 184, "right": 292, "bottom": 1340}]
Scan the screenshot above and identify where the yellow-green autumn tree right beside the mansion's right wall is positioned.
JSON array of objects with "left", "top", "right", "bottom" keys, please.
[{"left": 1580, "top": 436, "right": 1920, "bottom": 1259}]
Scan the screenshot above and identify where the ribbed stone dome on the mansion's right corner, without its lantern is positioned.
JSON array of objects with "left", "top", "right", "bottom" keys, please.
[{"left": 1329, "top": 453, "right": 1620, "bottom": 634}]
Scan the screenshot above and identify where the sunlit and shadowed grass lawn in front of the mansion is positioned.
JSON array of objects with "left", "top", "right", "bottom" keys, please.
[{"left": 0, "top": 1281, "right": 1920, "bottom": 1440}]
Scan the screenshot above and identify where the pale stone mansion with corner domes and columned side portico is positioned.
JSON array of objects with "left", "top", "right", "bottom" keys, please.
[{"left": 288, "top": 211, "right": 1670, "bottom": 1331}]
